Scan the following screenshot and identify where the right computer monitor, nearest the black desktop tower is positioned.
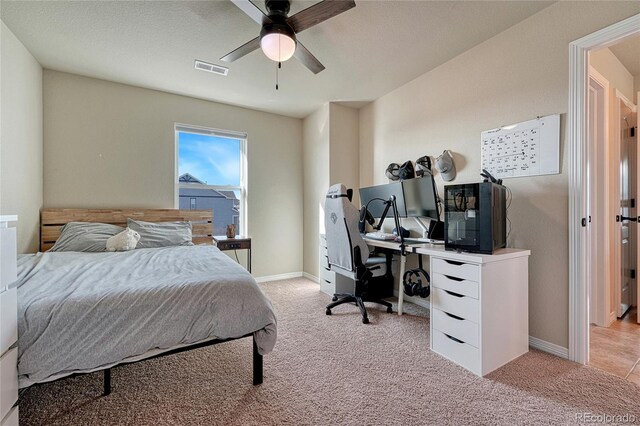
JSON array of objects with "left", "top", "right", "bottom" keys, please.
[{"left": 402, "top": 173, "right": 440, "bottom": 220}]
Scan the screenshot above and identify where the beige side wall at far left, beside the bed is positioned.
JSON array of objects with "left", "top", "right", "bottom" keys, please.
[{"left": 0, "top": 22, "right": 42, "bottom": 253}]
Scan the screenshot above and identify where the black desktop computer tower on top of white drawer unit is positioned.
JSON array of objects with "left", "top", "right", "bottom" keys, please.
[{"left": 444, "top": 182, "right": 507, "bottom": 254}]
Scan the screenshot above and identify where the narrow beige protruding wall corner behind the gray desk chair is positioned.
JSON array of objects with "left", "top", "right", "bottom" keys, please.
[{"left": 303, "top": 102, "right": 360, "bottom": 277}]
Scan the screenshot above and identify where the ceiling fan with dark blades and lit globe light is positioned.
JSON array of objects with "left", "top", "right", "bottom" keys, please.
[{"left": 220, "top": 0, "right": 356, "bottom": 74}]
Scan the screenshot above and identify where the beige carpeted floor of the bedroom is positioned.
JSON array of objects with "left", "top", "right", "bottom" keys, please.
[{"left": 20, "top": 278, "right": 640, "bottom": 425}]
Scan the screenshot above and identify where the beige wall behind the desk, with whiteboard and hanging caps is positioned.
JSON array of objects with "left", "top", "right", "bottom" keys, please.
[{"left": 360, "top": 2, "right": 640, "bottom": 347}]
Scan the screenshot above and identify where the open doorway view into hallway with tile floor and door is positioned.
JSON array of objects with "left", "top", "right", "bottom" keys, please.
[{"left": 587, "top": 49, "right": 640, "bottom": 384}]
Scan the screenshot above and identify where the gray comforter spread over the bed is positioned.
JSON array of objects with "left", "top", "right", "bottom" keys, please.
[{"left": 18, "top": 246, "right": 276, "bottom": 387}]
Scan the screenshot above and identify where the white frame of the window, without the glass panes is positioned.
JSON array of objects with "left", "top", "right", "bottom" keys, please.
[{"left": 173, "top": 123, "right": 249, "bottom": 235}]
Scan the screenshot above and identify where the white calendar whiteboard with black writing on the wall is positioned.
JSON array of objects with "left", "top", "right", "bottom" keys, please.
[{"left": 481, "top": 114, "right": 560, "bottom": 178}]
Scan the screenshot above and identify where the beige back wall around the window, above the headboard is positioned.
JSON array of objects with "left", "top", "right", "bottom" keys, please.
[{"left": 44, "top": 70, "right": 303, "bottom": 277}]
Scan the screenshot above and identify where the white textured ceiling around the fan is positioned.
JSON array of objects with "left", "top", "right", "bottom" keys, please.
[{"left": 0, "top": 0, "right": 553, "bottom": 117}]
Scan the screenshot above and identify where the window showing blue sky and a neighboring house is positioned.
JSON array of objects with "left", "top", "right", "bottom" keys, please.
[{"left": 175, "top": 124, "right": 247, "bottom": 235}]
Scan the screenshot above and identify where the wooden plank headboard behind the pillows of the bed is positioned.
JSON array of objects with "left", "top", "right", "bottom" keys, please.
[{"left": 40, "top": 209, "right": 213, "bottom": 251}]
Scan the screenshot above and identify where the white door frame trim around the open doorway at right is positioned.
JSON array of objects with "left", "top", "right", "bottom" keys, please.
[{"left": 568, "top": 14, "right": 640, "bottom": 364}]
